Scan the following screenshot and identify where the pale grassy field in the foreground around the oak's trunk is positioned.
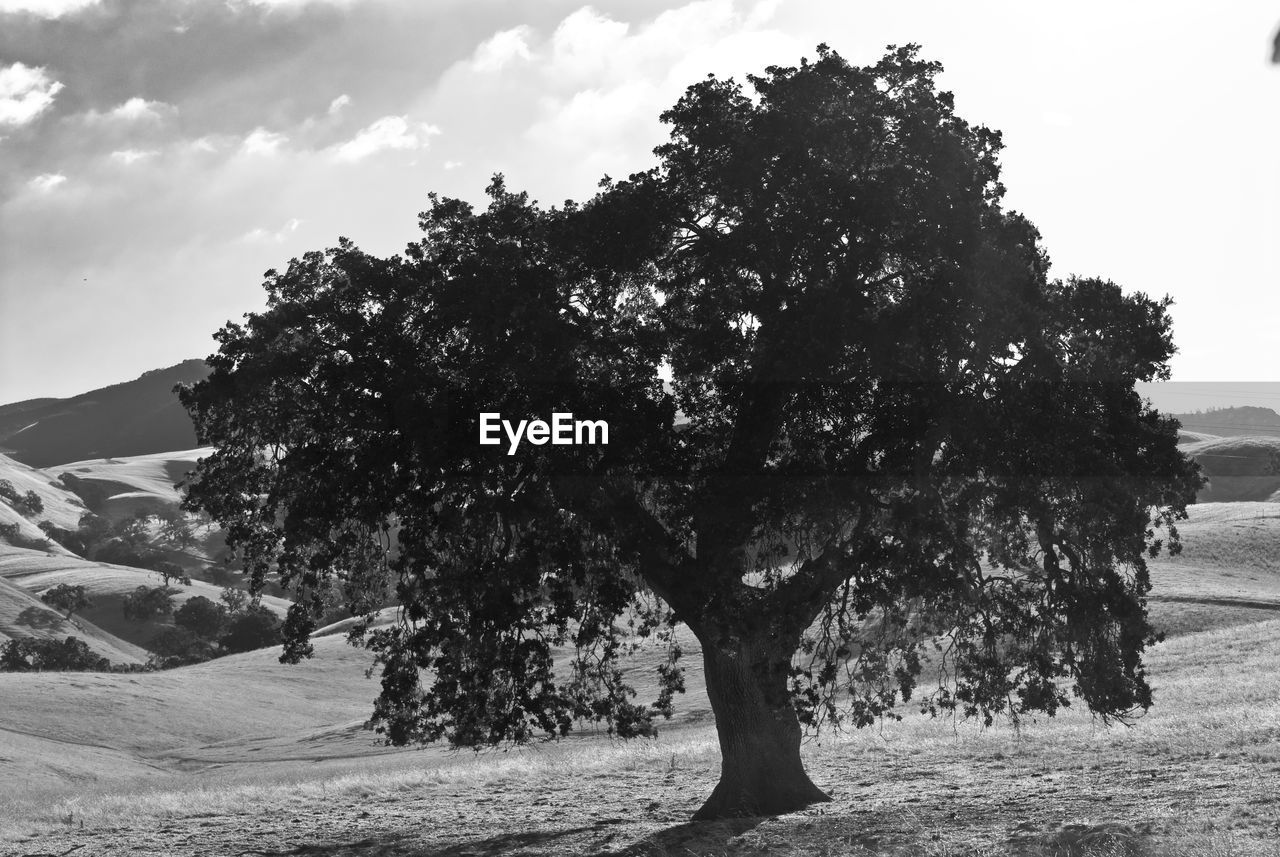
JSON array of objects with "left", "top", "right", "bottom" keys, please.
[{"left": 0, "top": 503, "right": 1280, "bottom": 857}]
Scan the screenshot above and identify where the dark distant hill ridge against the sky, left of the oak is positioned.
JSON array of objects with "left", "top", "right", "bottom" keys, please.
[{"left": 0, "top": 359, "right": 209, "bottom": 467}]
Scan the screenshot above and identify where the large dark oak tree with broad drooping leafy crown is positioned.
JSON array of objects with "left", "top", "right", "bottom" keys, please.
[{"left": 182, "top": 46, "right": 1199, "bottom": 817}]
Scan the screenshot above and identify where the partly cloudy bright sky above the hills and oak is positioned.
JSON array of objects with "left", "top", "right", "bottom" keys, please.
[{"left": 0, "top": 0, "right": 1280, "bottom": 405}]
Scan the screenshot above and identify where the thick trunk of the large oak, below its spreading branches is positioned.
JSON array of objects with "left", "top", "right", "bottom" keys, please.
[{"left": 694, "top": 640, "right": 831, "bottom": 821}]
